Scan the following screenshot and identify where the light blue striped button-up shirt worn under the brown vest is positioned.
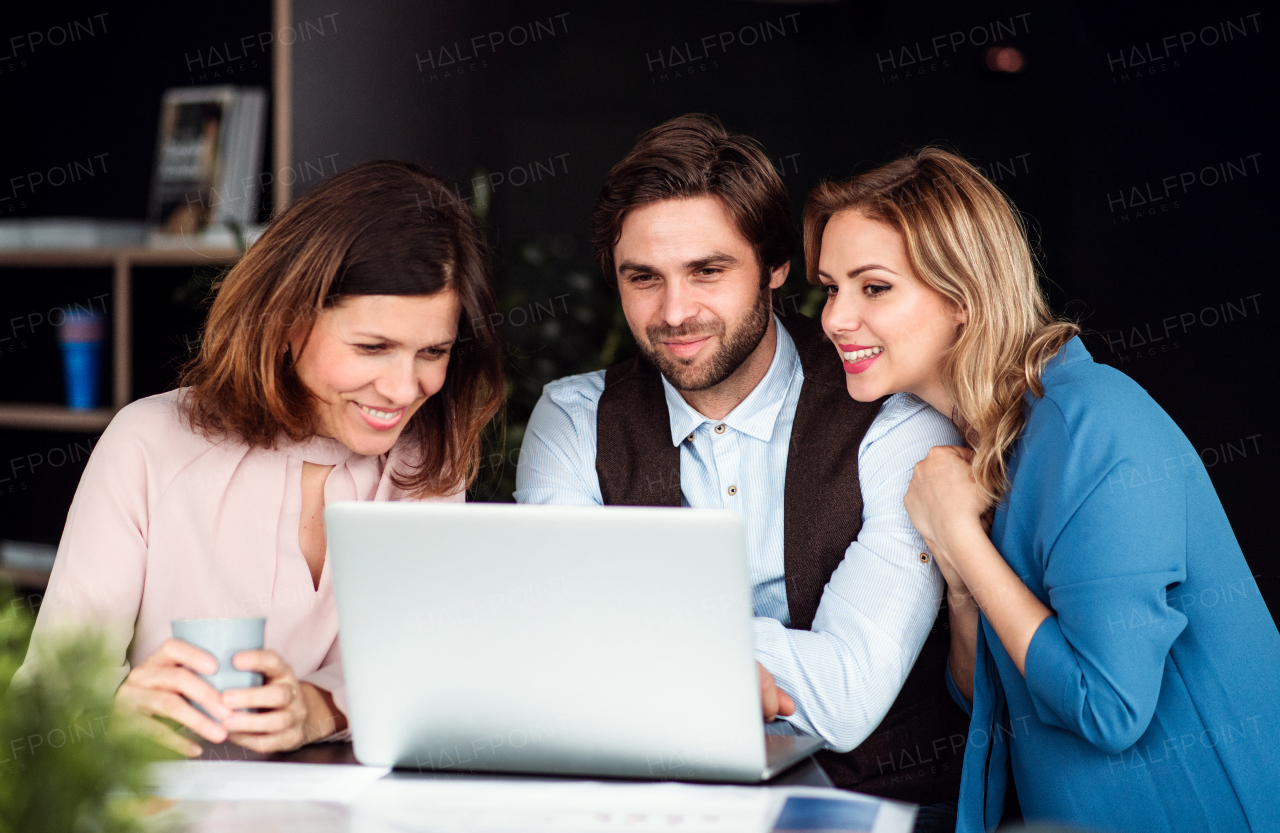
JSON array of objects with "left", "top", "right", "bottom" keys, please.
[{"left": 516, "top": 319, "right": 960, "bottom": 751}]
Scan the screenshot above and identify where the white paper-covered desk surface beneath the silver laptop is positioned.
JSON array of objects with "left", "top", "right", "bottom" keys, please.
[{"left": 145, "top": 743, "right": 914, "bottom": 833}]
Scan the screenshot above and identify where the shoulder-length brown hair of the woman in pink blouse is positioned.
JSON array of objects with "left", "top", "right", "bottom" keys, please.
[{"left": 180, "top": 161, "right": 506, "bottom": 496}]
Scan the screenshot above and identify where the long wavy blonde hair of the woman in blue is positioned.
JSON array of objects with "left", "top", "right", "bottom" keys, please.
[{"left": 804, "top": 147, "right": 1079, "bottom": 503}]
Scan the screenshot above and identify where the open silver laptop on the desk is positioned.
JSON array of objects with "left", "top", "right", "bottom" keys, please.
[{"left": 325, "top": 502, "right": 823, "bottom": 783}]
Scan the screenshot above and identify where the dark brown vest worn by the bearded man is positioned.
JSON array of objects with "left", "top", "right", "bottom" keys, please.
[{"left": 595, "top": 313, "right": 969, "bottom": 804}]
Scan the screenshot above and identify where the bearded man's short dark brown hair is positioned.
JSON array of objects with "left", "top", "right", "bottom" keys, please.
[{"left": 591, "top": 113, "right": 797, "bottom": 287}]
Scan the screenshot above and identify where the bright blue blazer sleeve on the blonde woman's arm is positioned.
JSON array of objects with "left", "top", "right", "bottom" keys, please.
[{"left": 1025, "top": 401, "right": 1187, "bottom": 755}]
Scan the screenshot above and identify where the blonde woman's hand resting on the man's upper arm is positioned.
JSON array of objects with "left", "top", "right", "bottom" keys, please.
[{"left": 904, "top": 445, "right": 991, "bottom": 594}]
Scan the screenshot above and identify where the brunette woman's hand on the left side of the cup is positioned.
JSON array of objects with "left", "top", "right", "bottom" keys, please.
[{"left": 115, "top": 639, "right": 232, "bottom": 758}]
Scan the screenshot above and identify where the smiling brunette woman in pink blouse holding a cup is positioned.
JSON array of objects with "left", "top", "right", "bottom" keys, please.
[{"left": 17, "top": 161, "right": 504, "bottom": 755}]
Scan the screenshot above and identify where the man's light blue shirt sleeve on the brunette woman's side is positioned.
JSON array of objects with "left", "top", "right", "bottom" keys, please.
[{"left": 515, "top": 372, "right": 604, "bottom": 505}]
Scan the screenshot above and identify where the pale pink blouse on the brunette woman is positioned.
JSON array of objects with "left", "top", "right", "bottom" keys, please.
[{"left": 28, "top": 390, "right": 463, "bottom": 714}]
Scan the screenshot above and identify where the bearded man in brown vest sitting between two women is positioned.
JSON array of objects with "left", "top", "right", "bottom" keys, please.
[{"left": 516, "top": 115, "right": 968, "bottom": 829}]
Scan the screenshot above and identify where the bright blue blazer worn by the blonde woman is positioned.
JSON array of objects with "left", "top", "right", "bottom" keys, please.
[{"left": 947, "top": 339, "right": 1280, "bottom": 833}]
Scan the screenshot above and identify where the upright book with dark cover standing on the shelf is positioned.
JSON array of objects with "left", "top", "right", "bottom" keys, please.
[{"left": 147, "top": 84, "right": 266, "bottom": 235}]
